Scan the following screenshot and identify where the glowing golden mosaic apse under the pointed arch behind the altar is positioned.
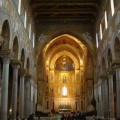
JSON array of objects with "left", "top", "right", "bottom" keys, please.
[{"left": 37, "top": 34, "right": 94, "bottom": 112}]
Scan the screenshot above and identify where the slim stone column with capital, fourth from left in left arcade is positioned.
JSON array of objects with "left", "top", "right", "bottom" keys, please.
[{"left": 26, "top": 74, "right": 31, "bottom": 117}]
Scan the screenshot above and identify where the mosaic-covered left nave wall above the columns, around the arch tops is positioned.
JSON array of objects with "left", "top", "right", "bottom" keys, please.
[{"left": 0, "top": 0, "right": 36, "bottom": 77}]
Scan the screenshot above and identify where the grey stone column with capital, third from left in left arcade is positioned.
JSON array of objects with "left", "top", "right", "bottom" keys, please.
[{"left": 19, "top": 69, "right": 26, "bottom": 119}]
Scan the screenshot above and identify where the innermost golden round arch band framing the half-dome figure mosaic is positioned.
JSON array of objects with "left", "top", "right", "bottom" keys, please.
[{"left": 50, "top": 50, "right": 79, "bottom": 70}]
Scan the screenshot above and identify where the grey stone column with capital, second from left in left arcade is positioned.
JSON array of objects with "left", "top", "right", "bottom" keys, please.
[{"left": 11, "top": 60, "right": 20, "bottom": 120}]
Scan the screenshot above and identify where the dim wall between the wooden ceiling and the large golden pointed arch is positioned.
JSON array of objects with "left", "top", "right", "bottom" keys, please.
[{"left": 36, "top": 23, "right": 95, "bottom": 60}]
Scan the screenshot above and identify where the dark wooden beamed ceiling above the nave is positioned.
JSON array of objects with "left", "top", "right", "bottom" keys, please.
[{"left": 30, "top": 0, "right": 101, "bottom": 23}]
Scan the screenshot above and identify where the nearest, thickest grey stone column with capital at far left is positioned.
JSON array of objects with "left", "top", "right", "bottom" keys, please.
[{"left": 0, "top": 50, "right": 12, "bottom": 120}]
